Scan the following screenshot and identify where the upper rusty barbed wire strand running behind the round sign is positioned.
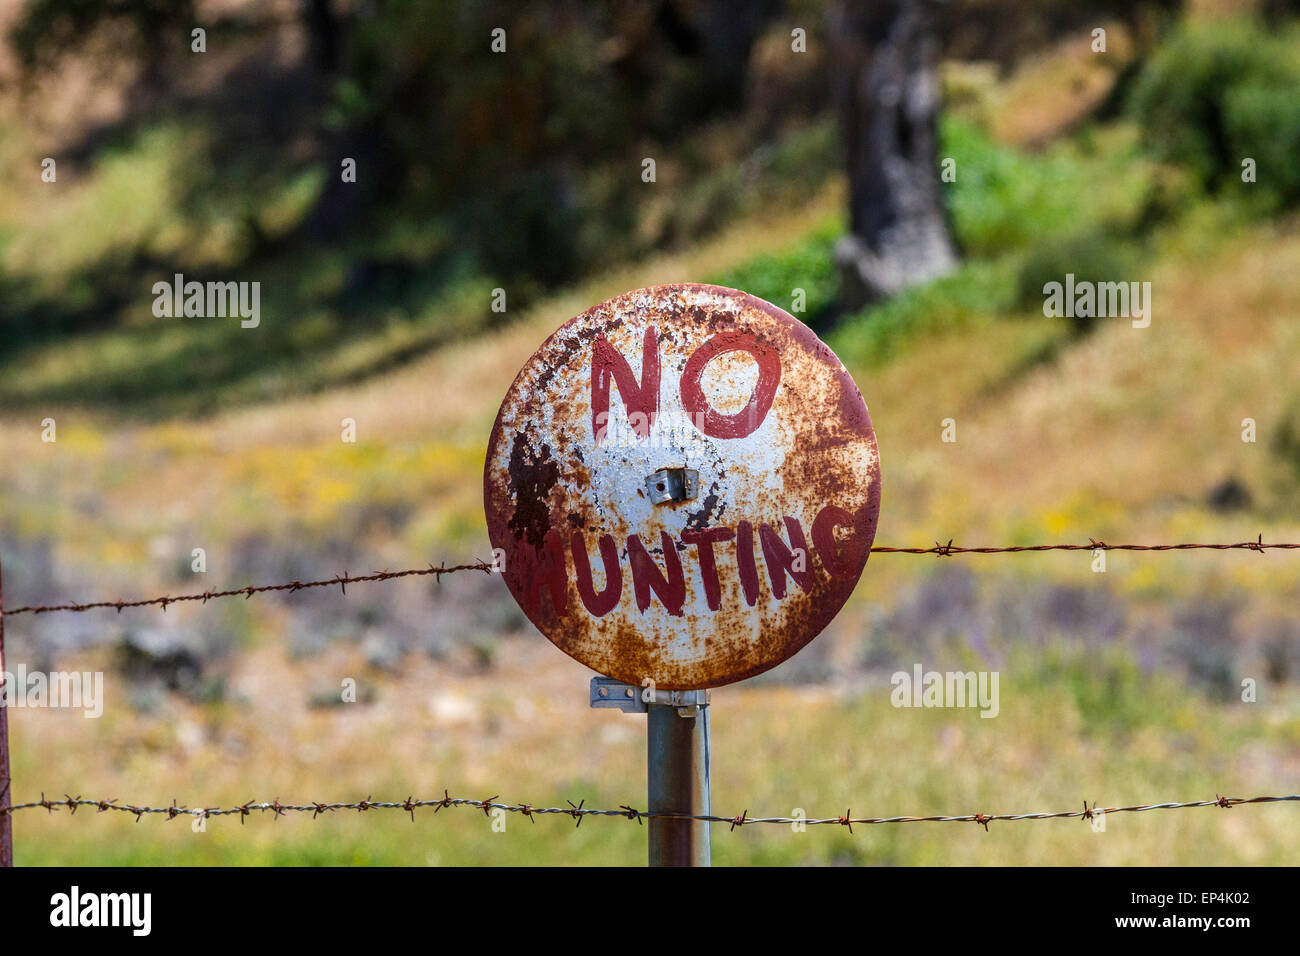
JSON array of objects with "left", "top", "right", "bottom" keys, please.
[{"left": 0, "top": 535, "right": 1300, "bottom": 618}]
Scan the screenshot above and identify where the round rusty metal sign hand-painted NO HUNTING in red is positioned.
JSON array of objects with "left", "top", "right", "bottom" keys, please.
[{"left": 484, "top": 285, "right": 880, "bottom": 689}]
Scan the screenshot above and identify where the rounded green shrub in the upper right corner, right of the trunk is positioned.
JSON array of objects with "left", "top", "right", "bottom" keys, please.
[{"left": 1128, "top": 20, "right": 1300, "bottom": 203}]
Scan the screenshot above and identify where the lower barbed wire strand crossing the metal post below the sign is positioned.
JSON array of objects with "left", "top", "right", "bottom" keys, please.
[{"left": 0, "top": 791, "right": 1300, "bottom": 832}]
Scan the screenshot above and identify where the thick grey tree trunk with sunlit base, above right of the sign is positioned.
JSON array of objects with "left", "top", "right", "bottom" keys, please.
[{"left": 831, "top": 0, "right": 957, "bottom": 311}]
